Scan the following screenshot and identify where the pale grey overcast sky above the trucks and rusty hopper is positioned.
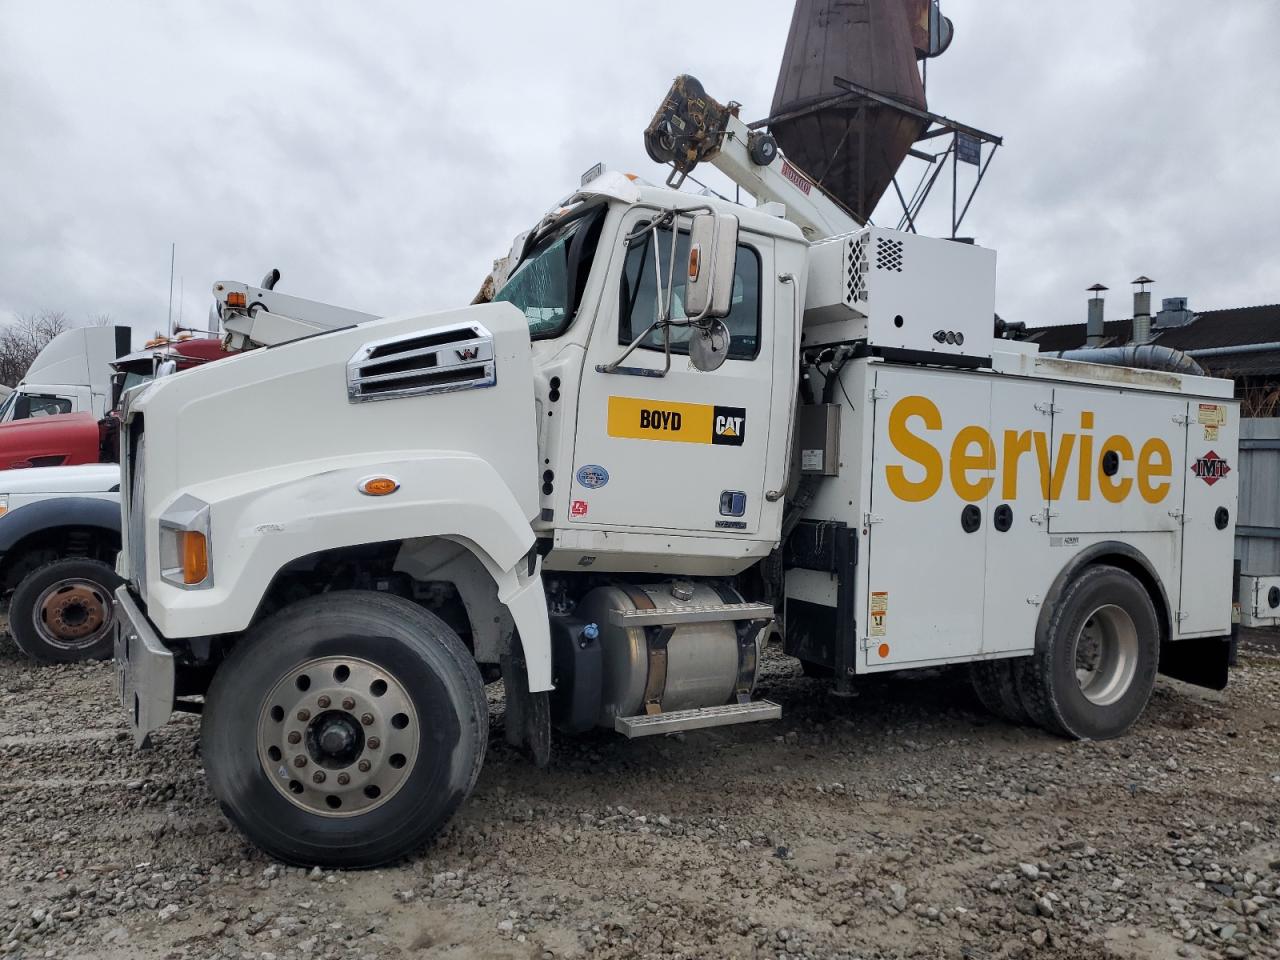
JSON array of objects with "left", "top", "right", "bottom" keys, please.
[{"left": 0, "top": 0, "right": 1280, "bottom": 343}]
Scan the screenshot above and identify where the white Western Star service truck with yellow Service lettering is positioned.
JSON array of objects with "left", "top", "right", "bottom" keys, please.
[{"left": 115, "top": 79, "right": 1238, "bottom": 867}]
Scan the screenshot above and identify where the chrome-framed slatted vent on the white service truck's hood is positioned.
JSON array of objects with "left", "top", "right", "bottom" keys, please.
[{"left": 347, "top": 324, "right": 498, "bottom": 403}]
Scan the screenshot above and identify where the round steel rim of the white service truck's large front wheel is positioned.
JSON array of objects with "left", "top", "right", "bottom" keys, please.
[{"left": 257, "top": 657, "right": 420, "bottom": 817}]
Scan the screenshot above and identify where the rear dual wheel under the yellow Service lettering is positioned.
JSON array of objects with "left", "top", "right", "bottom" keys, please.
[{"left": 1015, "top": 564, "right": 1160, "bottom": 740}]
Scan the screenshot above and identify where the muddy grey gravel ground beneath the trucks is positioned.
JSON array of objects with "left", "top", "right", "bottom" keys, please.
[{"left": 0, "top": 634, "right": 1280, "bottom": 960}]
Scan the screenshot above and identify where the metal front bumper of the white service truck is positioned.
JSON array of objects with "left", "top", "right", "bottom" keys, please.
[{"left": 115, "top": 585, "right": 174, "bottom": 749}]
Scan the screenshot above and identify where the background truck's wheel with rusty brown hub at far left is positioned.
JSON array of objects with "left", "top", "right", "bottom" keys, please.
[{"left": 9, "top": 557, "right": 122, "bottom": 663}]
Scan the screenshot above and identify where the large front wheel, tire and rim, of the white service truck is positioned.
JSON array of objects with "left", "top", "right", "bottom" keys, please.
[{"left": 201, "top": 591, "right": 489, "bottom": 868}]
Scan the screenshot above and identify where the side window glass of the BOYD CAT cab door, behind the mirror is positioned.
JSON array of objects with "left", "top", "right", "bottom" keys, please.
[{"left": 618, "top": 229, "right": 760, "bottom": 360}]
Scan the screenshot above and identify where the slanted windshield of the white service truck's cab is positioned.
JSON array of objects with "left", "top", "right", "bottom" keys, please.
[{"left": 494, "top": 206, "right": 605, "bottom": 340}]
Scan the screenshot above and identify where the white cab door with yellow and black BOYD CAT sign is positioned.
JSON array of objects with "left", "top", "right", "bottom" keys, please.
[{"left": 562, "top": 211, "right": 778, "bottom": 535}]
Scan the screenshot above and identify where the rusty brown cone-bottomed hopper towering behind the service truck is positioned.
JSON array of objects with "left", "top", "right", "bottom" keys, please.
[{"left": 769, "top": 0, "right": 951, "bottom": 220}]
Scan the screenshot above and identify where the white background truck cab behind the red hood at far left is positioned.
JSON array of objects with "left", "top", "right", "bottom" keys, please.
[{"left": 0, "top": 326, "right": 132, "bottom": 425}]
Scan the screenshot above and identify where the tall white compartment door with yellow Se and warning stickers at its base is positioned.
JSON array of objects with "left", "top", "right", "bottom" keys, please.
[{"left": 858, "top": 367, "right": 996, "bottom": 671}]
